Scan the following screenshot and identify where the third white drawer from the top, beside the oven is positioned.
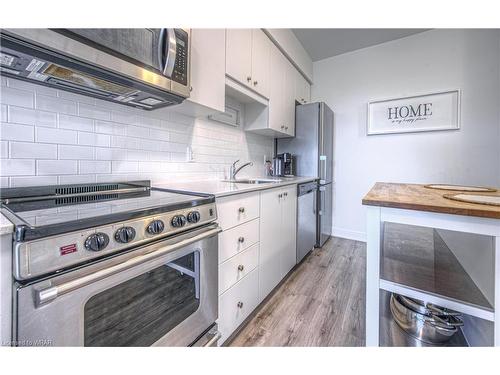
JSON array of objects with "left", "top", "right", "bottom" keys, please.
[{"left": 219, "top": 243, "right": 259, "bottom": 295}]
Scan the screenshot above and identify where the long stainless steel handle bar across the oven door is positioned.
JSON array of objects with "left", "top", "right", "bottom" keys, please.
[{"left": 35, "top": 227, "right": 222, "bottom": 306}]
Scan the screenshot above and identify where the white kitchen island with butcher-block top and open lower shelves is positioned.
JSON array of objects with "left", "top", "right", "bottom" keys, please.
[{"left": 362, "top": 182, "right": 500, "bottom": 346}]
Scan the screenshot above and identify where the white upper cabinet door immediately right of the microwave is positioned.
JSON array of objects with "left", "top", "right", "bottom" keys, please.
[{"left": 189, "top": 29, "right": 226, "bottom": 112}]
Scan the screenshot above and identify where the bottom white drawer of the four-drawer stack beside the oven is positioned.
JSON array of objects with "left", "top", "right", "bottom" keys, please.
[{"left": 217, "top": 269, "right": 259, "bottom": 343}]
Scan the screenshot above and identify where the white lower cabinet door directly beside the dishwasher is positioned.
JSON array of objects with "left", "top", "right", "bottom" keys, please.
[{"left": 281, "top": 185, "right": 297, "bottom": 277}]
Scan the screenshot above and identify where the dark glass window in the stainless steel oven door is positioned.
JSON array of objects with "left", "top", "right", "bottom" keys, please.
[{"left": 84, "top": 251, "right": 200, "bottom": 346}]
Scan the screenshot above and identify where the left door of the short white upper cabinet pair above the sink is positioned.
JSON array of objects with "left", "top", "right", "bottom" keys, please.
[{"left": 226, "top": 29, "right": 252, "bottom": 86}]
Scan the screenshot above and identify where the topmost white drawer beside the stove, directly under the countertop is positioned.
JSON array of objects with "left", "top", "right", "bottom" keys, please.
[{"left": 217, "top": 193, "right": 259, "bottom": 230}]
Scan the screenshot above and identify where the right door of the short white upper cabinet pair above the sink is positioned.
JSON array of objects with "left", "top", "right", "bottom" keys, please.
[{"left": 251, "top": 29, "right": 271, "bottom": 98}]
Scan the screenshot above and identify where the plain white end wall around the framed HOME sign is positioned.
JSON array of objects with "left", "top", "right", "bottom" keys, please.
[{"left": 312, "top": 30, "right": 500, "bottom": 239}]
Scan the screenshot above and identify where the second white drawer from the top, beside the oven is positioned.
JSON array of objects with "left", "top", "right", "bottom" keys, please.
[{"left": 219, "top": 219, "right": 259, "bottom": 264}]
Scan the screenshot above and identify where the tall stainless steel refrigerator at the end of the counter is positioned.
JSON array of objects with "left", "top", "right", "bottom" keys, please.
[{"left": 276, "top": 103, "right": 333, "bottom": 246}]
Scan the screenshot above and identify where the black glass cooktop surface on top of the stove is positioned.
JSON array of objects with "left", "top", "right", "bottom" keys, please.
[{"left": 0, "top": 181, "right": 215, "bottom": 241}]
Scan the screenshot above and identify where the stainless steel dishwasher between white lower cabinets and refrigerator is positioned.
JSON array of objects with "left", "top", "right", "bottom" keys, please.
[{"left": 297, "top": 181, "right": 318, "bottom": 263}]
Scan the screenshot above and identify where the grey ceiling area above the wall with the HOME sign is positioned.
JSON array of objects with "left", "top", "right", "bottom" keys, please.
[{"left": 292, "top": 29, "right": 429, "bottom": 61}]
